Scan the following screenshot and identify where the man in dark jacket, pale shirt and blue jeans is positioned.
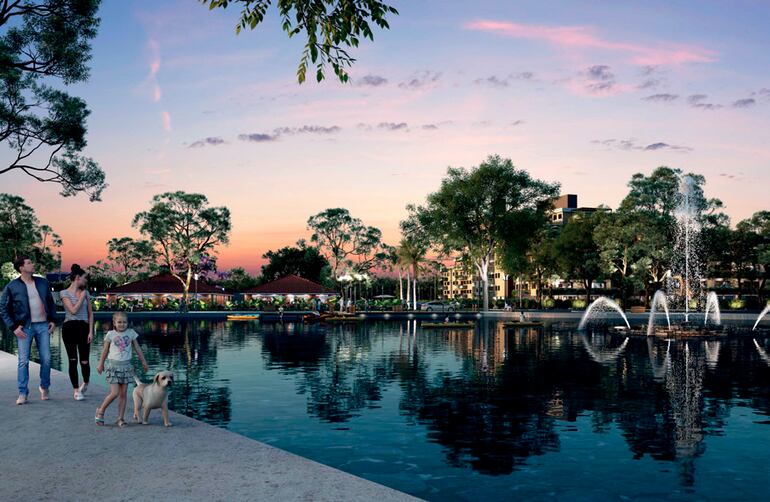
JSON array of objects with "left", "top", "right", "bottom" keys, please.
[{"left": 0, "top": 256, "right": 56, "bottom": 404}]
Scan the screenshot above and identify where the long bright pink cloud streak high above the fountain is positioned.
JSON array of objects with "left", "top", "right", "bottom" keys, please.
[{"left": 465, "top": 20, "right": 716, "bottom": 66}]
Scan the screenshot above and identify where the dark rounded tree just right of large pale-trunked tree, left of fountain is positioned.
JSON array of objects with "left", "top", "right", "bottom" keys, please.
[{"left": 556, "top": 214, "right": 602, "bottom": 303}]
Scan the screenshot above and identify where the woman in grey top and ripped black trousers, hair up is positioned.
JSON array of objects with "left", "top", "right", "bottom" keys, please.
[{"left": 59, "top": 264, "right": 94, "bottom": 401}]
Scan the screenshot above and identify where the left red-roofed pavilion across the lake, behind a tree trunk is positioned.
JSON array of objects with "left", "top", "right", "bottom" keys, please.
[{"left": 104, "top": 274, "right": 233, "bottom": 305}]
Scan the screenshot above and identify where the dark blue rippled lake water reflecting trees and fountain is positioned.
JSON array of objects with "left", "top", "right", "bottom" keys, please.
[{"left": 0, "top": 321, "right": 770, "bottom": 500}]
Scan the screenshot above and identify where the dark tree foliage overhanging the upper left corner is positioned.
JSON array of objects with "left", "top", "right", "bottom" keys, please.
[{"left": 0, "top": 0, "right": 107, "bottom": 201}]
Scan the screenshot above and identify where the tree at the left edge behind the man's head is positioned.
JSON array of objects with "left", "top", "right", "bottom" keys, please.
[{"left": 0, "top": 193, "right": 62, "bottom": 272}]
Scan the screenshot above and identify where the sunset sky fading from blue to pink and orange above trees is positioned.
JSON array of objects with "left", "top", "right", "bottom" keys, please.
[{"left": 0, "top": 0, "right": 770, "bottom": 272}]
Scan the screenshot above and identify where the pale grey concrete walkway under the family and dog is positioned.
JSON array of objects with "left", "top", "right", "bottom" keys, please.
[{"left": 0, "top": 351, "right": 416, "bottom": 502}]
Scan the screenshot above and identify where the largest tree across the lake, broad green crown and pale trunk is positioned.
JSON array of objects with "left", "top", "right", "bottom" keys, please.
[{"left": 417, "top": 155, "right": 559, "bottom": 310}]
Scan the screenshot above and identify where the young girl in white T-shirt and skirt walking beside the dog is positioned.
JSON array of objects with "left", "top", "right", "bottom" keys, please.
[{"left": 95, "top": 312, "right": 148, "bottom": 428}]
